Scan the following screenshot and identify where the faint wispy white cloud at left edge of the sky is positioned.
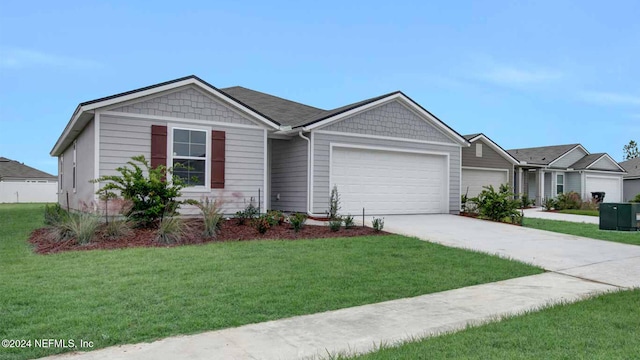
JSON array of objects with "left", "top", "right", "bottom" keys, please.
[{"left": 0, "top": 48, "right": 101, "bottom": 69}]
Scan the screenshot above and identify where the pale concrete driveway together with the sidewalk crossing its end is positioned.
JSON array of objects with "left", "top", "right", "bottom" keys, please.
[{"left": 42, "top": 215, "right": 640, "bottom": 360}]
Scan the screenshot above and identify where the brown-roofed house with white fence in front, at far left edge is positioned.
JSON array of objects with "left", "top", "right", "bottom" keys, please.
[{"left": 0, "top": 157, "right": 58, "bottom": 203}]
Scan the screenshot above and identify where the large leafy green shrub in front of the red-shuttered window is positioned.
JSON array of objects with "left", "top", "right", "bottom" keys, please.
[{"left": 91, "top": 155, "right": 186, "bottom": 227}]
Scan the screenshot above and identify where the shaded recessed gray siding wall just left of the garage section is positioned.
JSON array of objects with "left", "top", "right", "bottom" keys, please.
[{"left": 271, "top": 137, "right": 308, "bottom": 213}]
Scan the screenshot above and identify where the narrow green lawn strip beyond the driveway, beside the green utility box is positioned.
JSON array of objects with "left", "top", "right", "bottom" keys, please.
[{"left": 523, "top": 218, "right": 640, "bottom": 245}]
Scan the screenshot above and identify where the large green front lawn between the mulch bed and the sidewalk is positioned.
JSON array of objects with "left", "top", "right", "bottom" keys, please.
[{"left": 0, "top": 205, "right": 543, "bottom": 359}]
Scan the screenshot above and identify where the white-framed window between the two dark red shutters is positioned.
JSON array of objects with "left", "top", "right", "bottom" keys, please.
[{"left": 172, "top": 129, "right": 208, "bottom": 186}]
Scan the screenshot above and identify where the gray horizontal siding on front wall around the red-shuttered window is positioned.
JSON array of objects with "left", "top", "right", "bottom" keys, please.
[{"left": 99, "top": 114, "right": 265, "bottom": 214}]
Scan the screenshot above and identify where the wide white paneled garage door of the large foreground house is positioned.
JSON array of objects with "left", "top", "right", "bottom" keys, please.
[{"left": 331, "top": 147, "right": 449, "bottom": 215}]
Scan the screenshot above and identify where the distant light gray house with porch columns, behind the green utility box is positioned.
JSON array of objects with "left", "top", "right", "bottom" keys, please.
[{"left": 507, "top": 144, "right": 625, "bottom": 205}]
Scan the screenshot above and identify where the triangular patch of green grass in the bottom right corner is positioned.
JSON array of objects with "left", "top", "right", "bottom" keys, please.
[{"left": 339, "top": 290, "right": 640, "bottom": 360}]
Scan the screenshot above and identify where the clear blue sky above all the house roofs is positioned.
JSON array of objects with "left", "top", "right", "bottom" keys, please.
[{"left": 0, "top": 0, "right": 640, "bottom": 174}]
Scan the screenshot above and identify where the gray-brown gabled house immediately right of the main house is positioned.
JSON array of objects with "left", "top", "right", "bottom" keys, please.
[{"left": 462, "top": 134, "right": 519, "bottom": 197}]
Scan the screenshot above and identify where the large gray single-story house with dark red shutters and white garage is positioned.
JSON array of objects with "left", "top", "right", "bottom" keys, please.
[{"left": 51, "top": 76, "right": 469, "bottom": 215}]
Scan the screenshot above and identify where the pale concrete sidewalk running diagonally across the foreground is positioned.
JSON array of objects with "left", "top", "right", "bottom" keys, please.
[{"left": 46, "top": 273, "right": 618, "bottom": 360}]
